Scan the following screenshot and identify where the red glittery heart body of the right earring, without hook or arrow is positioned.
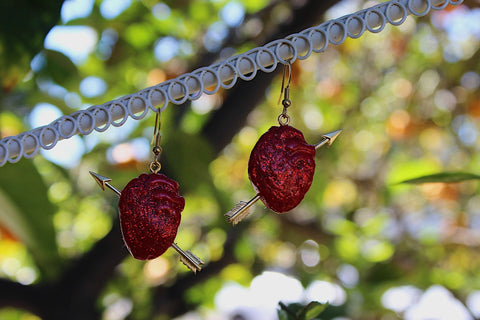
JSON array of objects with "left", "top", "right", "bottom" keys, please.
[{"left": 248, "top": 125, "right": 315, "bottom": 213}]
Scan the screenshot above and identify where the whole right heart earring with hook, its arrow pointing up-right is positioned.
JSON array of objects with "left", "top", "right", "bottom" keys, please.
[{"left": 225, "top": 63, "right": 342, "bottom": 225}]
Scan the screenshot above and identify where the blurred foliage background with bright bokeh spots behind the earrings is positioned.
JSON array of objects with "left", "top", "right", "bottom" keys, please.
[{"left": 0, "top": 0, "right": 480, "bottom": 320}]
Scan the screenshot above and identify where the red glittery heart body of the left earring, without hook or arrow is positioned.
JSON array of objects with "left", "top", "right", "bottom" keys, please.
[{"left": 118, "top": 173, "right": 185, "bottom": 260}]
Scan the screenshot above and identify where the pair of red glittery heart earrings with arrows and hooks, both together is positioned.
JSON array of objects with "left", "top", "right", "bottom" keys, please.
[{"left": 90, "top": 64, "right": 341, "bottom": 273}]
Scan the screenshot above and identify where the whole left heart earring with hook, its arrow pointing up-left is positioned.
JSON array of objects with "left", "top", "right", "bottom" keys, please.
[{"left": 90, "top": 110, "right": 203, "bottom": 273}]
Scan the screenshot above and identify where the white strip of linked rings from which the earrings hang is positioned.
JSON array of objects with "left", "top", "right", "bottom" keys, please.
[{"left": 0, "top": 0, "right": 463, "bottom": 167}]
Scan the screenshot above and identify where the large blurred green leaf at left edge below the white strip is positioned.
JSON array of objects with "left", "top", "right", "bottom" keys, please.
[{"left": 0, "top": 160, "right": 60, "bottom": 276}]
